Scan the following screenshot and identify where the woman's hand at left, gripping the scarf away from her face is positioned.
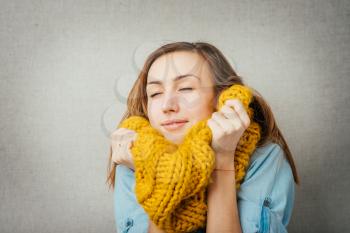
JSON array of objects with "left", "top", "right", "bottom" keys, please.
[{"left": 111, "top": 128, "right": 137, "bottom": 170}]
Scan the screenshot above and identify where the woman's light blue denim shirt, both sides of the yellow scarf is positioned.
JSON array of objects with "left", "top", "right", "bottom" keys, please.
[{"left": 114, "top": 143, "right": 295, "bottom": 233}]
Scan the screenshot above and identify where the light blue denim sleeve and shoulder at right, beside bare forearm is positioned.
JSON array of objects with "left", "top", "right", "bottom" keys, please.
[{"left": 237, "top": 143, "right": 295, "bottom": 233}]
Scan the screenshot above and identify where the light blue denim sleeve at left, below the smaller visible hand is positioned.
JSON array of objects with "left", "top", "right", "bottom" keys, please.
[{"left": 114, "top": 164, "right": 148, "bottom": 233}]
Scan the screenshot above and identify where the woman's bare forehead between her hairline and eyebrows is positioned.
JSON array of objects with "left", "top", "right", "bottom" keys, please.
[{"left": 147, "top": 51, "right": 211, "bottom": 83}]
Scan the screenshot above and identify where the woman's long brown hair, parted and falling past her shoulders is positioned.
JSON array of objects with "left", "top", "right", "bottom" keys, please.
[{"left": 106, "top": 42, "right": 300, "bottom": 189}]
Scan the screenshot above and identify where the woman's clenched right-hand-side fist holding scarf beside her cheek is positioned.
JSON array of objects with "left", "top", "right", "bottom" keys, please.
[{"left": 207, "top": 99, "right": 250, "bottom": 167}]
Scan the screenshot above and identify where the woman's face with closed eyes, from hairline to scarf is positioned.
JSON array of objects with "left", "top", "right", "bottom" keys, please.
[{"left": 146, "top": 51, "right": 215, "bottom": 144}]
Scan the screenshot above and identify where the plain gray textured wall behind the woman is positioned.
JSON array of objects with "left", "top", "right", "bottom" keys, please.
[{"left": 0, "top": 0, "right": 350, "bottom": 233}]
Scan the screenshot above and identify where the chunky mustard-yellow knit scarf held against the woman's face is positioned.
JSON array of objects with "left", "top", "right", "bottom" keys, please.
[{"left": 119, "top": 85, "right": 261, "bottom": 232}]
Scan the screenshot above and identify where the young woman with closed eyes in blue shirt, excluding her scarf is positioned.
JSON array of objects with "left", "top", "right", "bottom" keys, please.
[{"left": 107, "top": 42, "right": 299, "bottom": 233}]
